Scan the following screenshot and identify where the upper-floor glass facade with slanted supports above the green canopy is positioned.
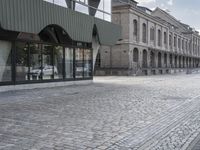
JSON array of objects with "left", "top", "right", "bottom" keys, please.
[{"left": 44, "top": 0, "right": 111, "bottom": 22}]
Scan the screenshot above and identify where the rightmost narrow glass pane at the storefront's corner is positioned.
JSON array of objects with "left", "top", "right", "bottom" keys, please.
[{"left": 83, "top": 49, "right": 92, "bottom": 77}]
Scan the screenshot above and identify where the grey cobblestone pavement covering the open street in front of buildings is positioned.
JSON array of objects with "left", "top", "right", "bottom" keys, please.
[{"left": 0, "top": 74, "right": 200, "bottom": 150}]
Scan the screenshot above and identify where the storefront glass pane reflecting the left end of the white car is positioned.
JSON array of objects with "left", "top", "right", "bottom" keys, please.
[{"left": 29, "top": 44, "right": 42, "bottom": 80}]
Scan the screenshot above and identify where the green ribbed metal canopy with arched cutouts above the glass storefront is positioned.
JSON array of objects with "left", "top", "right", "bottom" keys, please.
[{"left": 0, "top": 0, "right": 121, "bottom": 45}]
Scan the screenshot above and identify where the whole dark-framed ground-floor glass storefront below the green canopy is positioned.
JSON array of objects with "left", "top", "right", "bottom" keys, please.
[{"left": 0, "top": 41, "right": 93, "bottom": 84}]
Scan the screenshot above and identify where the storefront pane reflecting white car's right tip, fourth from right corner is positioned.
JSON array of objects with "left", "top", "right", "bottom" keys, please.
[{"left": 54, "top": 46, "right": 63, "bottom": 79}]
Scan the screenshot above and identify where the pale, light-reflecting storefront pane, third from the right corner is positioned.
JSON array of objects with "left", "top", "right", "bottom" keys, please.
[{"left": 65, "top": 48, "right": 74, "bottom": 79}]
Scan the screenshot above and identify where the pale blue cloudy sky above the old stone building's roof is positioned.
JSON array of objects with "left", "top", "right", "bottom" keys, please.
[{"left": 135, "top": 0, "right": 200, "bottom": 32}]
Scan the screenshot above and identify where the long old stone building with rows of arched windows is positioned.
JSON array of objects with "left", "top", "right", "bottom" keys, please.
[{"left": 96, "top": 0, "right": 200, "bottom": 75}]
